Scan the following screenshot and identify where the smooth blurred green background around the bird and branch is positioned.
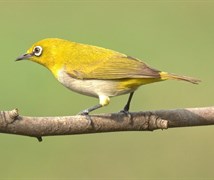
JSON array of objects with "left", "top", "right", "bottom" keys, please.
[{"left": 0, "top": 0, "right": 214, "bottom": 179}]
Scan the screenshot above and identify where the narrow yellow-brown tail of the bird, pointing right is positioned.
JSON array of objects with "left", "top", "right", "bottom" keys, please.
[{"left": 160, "top": 72, "right": 201, "bottom": 84}]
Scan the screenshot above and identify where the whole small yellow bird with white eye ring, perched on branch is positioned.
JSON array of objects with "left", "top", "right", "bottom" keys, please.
[{"left": 16, "top": 38, "right": 199, "bottom": 115}]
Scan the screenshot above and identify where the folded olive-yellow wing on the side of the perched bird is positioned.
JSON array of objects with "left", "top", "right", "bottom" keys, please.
[{"left": 66, "top": 55, "right": 160, "bottom": 79}]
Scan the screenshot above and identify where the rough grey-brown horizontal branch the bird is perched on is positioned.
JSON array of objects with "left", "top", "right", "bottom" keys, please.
[{"left": 0, "top": 107, "right": 214, "bottom": 141}]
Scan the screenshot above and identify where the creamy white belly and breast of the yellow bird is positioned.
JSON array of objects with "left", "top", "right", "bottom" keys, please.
[{"left": 57, "top": 70, "right": 133, "bottom": 97}]
